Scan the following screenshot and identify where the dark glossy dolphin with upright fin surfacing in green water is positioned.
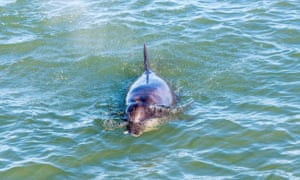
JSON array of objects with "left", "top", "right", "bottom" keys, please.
[{"left": 126, "top": 44, "right": 176, "bottom": 137}]
